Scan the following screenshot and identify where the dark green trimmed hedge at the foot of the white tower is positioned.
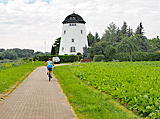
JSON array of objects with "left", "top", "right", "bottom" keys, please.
[{"left": 38, "top": 55, "right": 82, "bottom": 63}]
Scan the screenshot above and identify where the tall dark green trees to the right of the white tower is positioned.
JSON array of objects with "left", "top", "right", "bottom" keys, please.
[{"left": 87, "top": 21, "right": 160, "bottom": 61}]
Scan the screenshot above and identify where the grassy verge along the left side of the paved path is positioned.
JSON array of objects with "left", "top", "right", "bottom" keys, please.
[{"left": 0, "top": 61, "right": 44, "bottom": 94}]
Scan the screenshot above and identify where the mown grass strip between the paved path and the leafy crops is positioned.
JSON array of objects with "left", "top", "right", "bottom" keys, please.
[{"left": 53, "top": 66, "right": 138, "bottom": 119}]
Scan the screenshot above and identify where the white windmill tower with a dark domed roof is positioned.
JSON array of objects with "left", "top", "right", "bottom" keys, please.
[{"left": 59, "top": 12, "right": 88, "bottom": 55}]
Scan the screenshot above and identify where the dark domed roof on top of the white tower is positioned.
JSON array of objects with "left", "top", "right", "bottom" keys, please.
[{"left": 62, "top": 13, "right": 86, "bottom": 24}]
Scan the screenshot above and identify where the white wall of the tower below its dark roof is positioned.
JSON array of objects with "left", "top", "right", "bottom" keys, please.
[{"left": 59, "top": 23, "right": 88, "bottom": 55}]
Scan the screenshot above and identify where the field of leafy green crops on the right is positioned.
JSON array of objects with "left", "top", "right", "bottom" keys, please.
[{"left": 69, "top": 62, "right": 160, "bottom": 119}]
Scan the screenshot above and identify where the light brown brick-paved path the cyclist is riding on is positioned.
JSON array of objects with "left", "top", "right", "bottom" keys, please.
[{"left": 0, "top": 66, "right": 75, "bottom": 119}]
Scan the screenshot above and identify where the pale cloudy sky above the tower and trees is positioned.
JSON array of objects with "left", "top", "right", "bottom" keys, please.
[{"left": 0, "top": 0, "right": 160, "bottom": 52}]
